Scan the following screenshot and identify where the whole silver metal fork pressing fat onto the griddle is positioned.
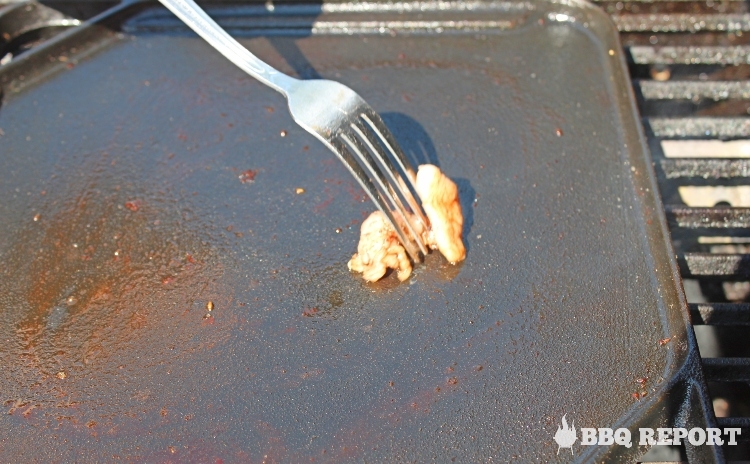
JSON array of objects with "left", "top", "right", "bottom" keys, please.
[{"left": 160, "top": 0, "right": 429, "bottom": 262}]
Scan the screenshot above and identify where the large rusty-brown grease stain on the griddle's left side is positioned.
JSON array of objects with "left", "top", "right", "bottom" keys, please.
[{"left": 0, "top": 157, "right": 236, "bottom": 428}]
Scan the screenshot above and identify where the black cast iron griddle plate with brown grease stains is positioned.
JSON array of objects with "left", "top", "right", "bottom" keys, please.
[{"left": 0, "top": 2, "right": 685, "bottom": 462}]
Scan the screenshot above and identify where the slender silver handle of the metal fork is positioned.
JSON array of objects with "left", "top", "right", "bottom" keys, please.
[{"left": 159, "top": 0, "right": 298, "bottom": 96}]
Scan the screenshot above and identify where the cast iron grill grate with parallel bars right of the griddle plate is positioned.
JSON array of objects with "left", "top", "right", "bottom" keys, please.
[{"left": 599, "top": 0, "right": 750, "bottom": 460}]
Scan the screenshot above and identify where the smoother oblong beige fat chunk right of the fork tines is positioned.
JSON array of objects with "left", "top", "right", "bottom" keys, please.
[{"left": 416, "top": 164, "right": 466, "bottom": 264}]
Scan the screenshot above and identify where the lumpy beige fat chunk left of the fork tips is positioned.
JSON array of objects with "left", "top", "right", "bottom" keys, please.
[{"left": 348, "top": 211, "right": 412, "bottom": 282}]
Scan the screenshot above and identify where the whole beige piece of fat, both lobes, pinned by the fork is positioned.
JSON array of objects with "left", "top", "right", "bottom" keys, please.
[{"left": 348, "top": 164, "right": 466, "bottom": 282}]
